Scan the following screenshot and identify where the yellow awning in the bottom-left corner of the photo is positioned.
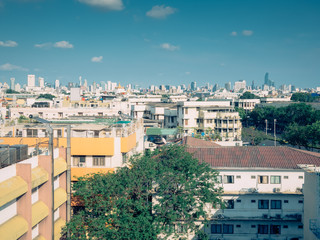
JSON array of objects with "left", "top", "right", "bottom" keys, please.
[{"left": 0, "top": 215, "right": 28, "bottom": 240}]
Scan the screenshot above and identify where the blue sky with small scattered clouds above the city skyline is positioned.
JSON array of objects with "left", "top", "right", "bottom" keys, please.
[{"left": 0, "top": 0, "right": 320, "bottom": 88}]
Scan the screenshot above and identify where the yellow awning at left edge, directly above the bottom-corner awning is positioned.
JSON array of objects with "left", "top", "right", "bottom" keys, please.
[{"left": 0, "top": 176, "right": 28, "bottom": 207}]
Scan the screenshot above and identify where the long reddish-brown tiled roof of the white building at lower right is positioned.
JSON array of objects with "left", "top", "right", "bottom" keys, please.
[{"left": 187, "top": 146, "right": 320, "bottom": 169}]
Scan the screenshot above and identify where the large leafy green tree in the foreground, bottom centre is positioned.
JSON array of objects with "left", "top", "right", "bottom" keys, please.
[{"left": 65, "top": 145, "right": 222, "bottom": 240}]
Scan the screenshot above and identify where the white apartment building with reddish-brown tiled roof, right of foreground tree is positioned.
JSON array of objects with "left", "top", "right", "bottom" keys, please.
[{"left": 187, "top": 146, "right": 320, "bottom": 240}]
